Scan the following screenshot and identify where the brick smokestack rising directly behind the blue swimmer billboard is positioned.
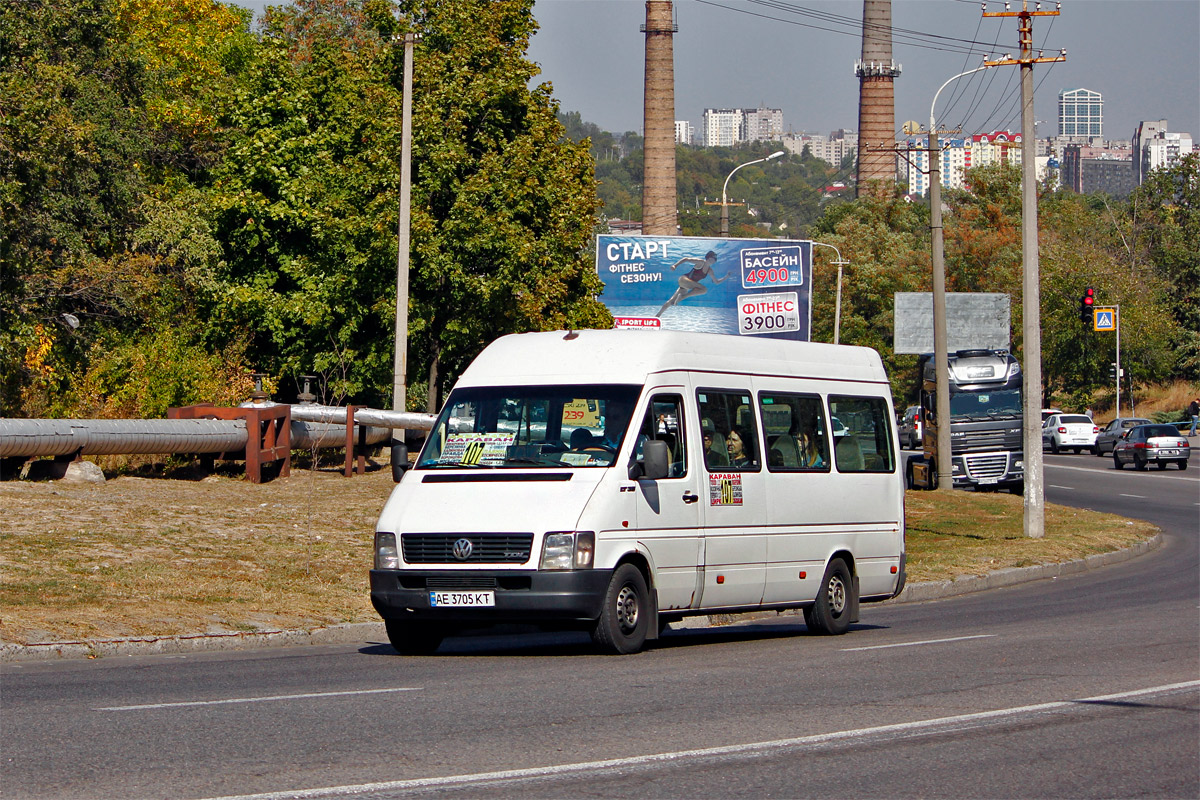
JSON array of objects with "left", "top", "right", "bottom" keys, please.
[{"left": 642, "top": 0, "right": 678, "bottom": 236}]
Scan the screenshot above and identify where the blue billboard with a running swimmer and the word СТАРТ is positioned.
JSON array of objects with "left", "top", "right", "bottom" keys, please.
[{"left": 596, "top": 234, "right": 812, "bottom": 342}]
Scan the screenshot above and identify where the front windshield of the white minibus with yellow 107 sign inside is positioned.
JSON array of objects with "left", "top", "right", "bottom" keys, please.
[{"left": 416, "top": 384, "right": 641, "bottom": 469}]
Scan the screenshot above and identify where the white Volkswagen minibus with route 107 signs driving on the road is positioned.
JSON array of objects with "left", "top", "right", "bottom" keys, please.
[{"left": 371, "top": 330, "right": 905, "bottom": 654}]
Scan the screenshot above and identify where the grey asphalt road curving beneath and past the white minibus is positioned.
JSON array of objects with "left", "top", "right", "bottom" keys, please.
[{"left": 0, "top": 455, "right": 1200, "bottom": 798}]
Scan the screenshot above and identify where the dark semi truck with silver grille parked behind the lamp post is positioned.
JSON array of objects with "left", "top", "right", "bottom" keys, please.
[{"left": 905, "top": 349, "right": 1025, "bottom": 494}]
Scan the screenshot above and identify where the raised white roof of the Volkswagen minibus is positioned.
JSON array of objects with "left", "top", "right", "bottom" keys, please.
[{"left": 458, "top": 330, "right": 888, "bottom": 386}]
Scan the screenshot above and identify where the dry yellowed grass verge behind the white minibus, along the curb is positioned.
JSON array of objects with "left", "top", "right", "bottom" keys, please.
[{"left": 0, "top": 469, "right": 1153, "bottom": 644}]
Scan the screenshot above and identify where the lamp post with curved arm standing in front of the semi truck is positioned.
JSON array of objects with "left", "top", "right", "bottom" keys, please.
[{"left": 929, "top": 66, "right": 988, "bottom": 492}]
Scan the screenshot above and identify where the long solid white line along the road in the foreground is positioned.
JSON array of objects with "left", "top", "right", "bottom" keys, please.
[{"left": 196, "top": 680, "right": 1200, "bottom": 800}]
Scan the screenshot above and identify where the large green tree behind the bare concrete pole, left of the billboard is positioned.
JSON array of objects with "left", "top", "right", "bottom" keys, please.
[{"left": 205, "top": 0, "right": 611, "bottom": 408}]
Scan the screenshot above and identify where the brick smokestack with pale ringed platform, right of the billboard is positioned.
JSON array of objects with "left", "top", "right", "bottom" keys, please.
[{"left": 854, "top": 0, "right": 900, "bottom": 197}]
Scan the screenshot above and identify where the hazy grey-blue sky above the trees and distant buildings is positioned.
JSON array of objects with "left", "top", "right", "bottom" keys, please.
[{"left": 239, "top": 0, "right": 1200, "bottom": 139}]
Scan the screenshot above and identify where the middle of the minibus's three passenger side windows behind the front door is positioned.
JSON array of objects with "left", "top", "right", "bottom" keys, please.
[{"left": 758, "top": 392, "right": 829, "bottom": 473}]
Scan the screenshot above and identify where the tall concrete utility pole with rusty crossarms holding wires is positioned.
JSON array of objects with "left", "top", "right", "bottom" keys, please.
[{"left": 983, "top": 0, "right": 1067, "bottom": 539}]
